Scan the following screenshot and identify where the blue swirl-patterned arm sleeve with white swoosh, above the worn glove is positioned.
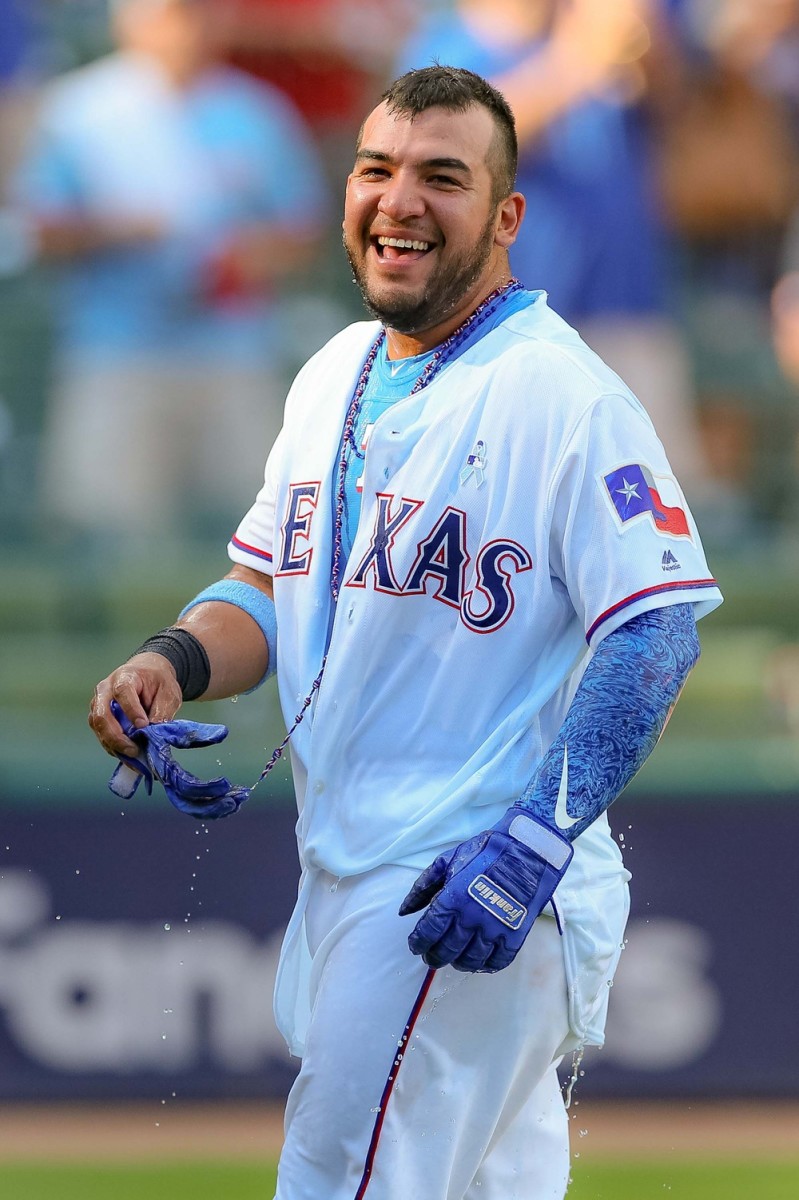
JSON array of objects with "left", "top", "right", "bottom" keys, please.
[{"left": 517, "top": 604, "right": 699, "bottom": 841}]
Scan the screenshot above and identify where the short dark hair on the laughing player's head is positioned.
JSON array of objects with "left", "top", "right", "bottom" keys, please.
[{"left": 382, "top": 62, "right": 518, "bottom": 200}]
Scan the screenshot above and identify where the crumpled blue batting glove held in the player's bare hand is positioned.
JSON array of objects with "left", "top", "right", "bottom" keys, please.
[{"left": 108, "top": 700, "right": 250, "bottom": 821}]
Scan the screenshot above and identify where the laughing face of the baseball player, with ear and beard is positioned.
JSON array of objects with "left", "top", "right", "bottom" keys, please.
[{"left": 344, "top": 87, "right": 515, "bottom": 343}]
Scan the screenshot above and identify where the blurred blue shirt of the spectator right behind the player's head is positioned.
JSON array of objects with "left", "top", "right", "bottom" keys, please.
[{"left": 396, "top": 12, "right": 669, "bottom": 323}]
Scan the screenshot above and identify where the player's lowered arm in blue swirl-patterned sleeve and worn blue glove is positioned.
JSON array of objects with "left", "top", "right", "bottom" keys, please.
[{"left": 400, "top": 604, "right": 699, "bottom": 972}]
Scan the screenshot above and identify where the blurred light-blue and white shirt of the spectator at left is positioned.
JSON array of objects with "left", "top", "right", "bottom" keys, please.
[{"left": 17, "top": 53, "right": 326, "bottom": 366}]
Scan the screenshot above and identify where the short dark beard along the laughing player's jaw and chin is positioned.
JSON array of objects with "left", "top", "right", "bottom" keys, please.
[{"left": 343, "top": 214, "right": 494, "bottom": 335}]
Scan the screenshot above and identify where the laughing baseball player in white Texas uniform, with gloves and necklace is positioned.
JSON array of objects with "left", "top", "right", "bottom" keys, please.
[{"left": 90, "top": 66, "right": 721, "bottom": 1200}]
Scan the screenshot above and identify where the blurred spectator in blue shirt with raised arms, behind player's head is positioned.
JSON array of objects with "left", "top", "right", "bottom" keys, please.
[{"left": 396, "top": 0, "right": 703, "bottom": 503}]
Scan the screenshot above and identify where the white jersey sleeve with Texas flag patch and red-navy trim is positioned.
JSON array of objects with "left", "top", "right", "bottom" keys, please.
[{"left": 549, "top": 395, "right": 722, "bottom": 646}]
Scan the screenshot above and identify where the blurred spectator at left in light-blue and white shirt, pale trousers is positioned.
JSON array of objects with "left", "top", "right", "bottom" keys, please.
[{"left": 11, "top": 0, "right": 325, "bottom": 545}]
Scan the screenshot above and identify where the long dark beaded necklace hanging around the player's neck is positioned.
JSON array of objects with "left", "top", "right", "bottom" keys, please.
[{"left": 252, "top": 278, "right": 522, "bottom": 790}]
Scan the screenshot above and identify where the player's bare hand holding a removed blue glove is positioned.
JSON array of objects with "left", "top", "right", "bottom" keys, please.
[{"left": 89, "top": 652, "right": 182, "bottom": 757}]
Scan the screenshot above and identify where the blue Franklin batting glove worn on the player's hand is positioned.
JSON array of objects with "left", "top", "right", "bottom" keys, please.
[{"left": 400, "top": 804, "right": 573, "bottom": 972}]
